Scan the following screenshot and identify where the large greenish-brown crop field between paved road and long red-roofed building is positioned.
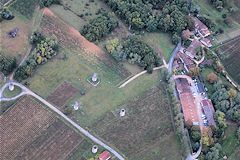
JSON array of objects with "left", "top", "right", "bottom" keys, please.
[{"left": 92, "top": 83, "right": 181, "bottom": 160}]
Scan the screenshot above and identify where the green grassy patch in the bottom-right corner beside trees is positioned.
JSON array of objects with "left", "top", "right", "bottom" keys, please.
[{"left": 222, "top": 124, "right": 240, "bottom": 159}]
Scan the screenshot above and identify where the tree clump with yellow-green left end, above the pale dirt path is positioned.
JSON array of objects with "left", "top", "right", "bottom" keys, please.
[{"left": 106, "top": 36, "right": 162, "bottom": 73}]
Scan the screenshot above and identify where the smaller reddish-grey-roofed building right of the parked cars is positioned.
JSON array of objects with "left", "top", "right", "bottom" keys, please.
[{"left": 201, "top": 99, "right": 216, "bottom": 126}]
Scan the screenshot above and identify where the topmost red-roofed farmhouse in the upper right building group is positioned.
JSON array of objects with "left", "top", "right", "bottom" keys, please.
[{"left": 192, "top": 17, "right": 211, "bottom": 37}]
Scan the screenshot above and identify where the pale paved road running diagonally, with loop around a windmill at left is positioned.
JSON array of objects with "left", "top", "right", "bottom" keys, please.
[{"left": 0, "top": 82, "right": 124, "bottom": 160}]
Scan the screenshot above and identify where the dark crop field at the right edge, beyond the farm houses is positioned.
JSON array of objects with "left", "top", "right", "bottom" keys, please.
[{"left": 219, "top": 36, "right": 240, "bottom": 84}]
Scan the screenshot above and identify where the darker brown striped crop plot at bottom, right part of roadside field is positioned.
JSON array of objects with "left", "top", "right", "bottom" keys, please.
[{"left": 16, "top": 120, "right": 83, "bottom": 160}]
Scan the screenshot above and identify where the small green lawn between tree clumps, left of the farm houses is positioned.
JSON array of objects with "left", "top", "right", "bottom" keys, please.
[{"left": 143, "top": 32, "right": 175, "bottom": 62}]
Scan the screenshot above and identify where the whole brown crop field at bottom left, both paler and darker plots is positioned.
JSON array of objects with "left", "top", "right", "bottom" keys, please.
[{"left": 0, "top": 96, "right": 83, "bottom": 160}]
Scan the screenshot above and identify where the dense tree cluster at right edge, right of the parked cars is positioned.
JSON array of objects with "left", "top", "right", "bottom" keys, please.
[{"left": 211, "top": 82, "right": 240, "bottom": 122}]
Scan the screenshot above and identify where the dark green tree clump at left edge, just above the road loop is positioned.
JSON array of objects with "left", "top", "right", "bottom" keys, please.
[{"left": 0, "top": 53, "right": 17, "bottom": 76}]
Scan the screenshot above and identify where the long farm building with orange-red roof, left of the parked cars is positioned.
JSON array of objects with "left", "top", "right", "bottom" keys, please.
[{"left": 176, "top": 78, "right": 199, "bottom": 125}]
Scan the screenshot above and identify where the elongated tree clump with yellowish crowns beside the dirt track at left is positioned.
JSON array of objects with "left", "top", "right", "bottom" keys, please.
[{"left": 14, "top": 32, "right": 58, "bottom": 81}]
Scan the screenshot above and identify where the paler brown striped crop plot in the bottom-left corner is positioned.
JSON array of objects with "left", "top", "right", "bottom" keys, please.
[{"left": 0, "top": 97, "right": 54, "bottom": 159}]
